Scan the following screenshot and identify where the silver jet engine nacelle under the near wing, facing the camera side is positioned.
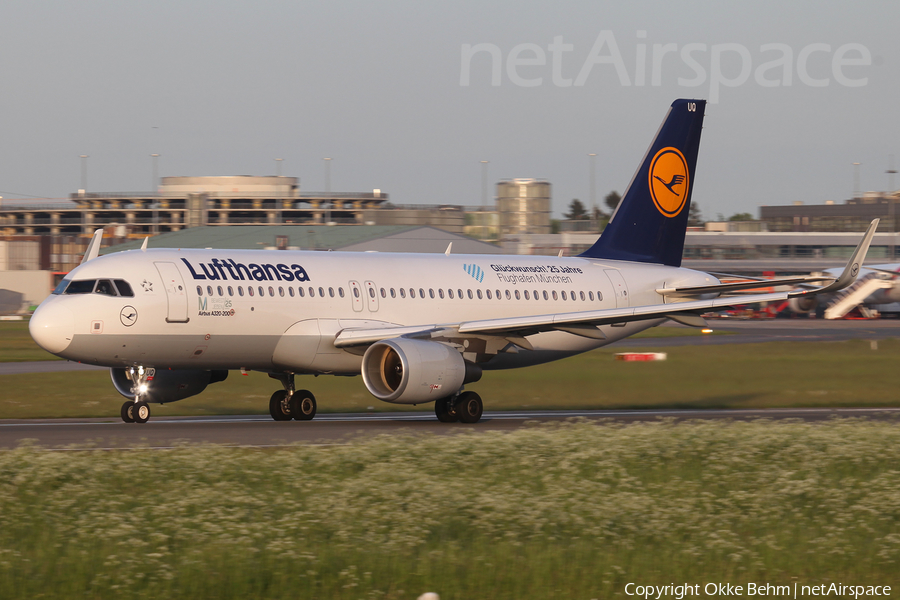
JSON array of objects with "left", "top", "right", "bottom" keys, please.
[{"left": 362, "top": 338, "right": 481, "bottom": 404}]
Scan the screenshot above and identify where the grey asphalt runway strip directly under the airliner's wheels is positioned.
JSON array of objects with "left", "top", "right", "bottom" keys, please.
[{"left": 0, "top": 408, "right": 900, "bottom": 450}]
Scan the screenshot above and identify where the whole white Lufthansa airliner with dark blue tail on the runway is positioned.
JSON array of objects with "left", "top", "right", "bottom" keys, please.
[{"left": 29, "top": 100, "right": 877, "bottom": 423}]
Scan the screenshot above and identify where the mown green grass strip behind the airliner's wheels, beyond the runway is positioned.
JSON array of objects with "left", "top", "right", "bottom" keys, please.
[{"left": 0, "top": 340, "right": 900, "bottom": 418}]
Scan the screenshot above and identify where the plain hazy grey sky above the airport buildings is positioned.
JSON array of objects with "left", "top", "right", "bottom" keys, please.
[{"left": 0, "top": 0, "right": 900, "bottom": 219}]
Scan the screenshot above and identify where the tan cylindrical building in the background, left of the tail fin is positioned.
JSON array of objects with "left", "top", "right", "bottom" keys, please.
[{"left": 497, "top": 179, "right": 550, "bottom": 234}]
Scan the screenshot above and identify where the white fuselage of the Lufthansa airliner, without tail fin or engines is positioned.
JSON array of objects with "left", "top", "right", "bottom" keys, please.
[{"left": 31, "top": 249, "right": 716, "bottom": 374}]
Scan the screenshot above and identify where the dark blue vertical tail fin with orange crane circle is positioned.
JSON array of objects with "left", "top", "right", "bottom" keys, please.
[{"left": 581, "top": 100, "right": 706, "bottom": 267}]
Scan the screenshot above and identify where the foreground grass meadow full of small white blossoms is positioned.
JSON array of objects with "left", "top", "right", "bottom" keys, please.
[{"left": 0, "top": 420, "right": 900, "bottom": 600}]
